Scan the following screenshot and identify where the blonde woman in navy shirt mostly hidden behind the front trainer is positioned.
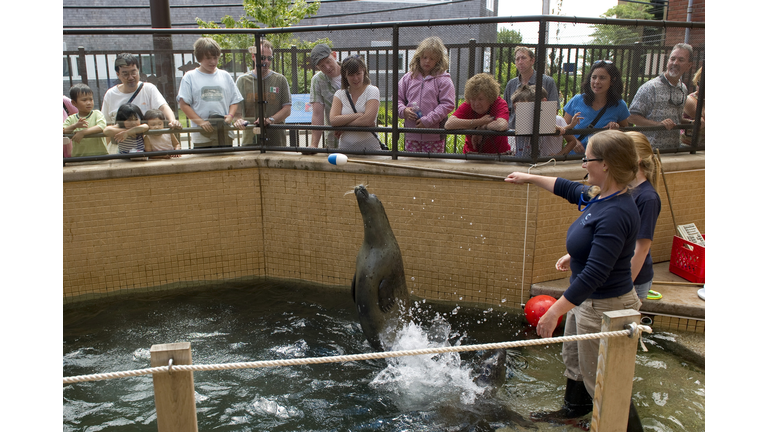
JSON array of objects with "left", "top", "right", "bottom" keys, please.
[{"left": 625, "top": 131, "right": 661, "bottom": 300}]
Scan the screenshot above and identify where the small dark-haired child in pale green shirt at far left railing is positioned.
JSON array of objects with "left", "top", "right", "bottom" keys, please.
[{"left": 64, "top": 84, "right": 107, "bottom": 157}]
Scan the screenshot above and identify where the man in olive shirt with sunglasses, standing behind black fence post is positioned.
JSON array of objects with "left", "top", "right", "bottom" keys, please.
[{"left": 237, "top": 39, "right": 291, "bottom": 147}]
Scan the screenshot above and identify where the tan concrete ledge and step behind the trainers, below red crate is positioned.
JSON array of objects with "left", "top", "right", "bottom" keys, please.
[{"left": 531, "top": 261, "right": 705, "bottom": 368}]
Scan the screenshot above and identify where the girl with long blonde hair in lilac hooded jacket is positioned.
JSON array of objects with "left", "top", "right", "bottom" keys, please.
[{"left": 397, "top": 36, "right": 456, "bottom": 153}]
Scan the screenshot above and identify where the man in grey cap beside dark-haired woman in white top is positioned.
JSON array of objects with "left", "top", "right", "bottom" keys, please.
[{"left": 309, "top": 44, "right": 341, "bottom": 148}]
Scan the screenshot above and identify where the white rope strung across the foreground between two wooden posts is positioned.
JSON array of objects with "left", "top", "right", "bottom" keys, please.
[{"left": 64, "top": 323, "right": 653, "bottom": 384}]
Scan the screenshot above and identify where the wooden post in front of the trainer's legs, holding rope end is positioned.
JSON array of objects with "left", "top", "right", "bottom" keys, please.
[{"left": 590, "top": 309, "right": 640, "bottom": 432}]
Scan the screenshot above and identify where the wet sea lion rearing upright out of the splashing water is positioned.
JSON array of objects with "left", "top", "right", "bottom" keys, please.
[{"left": 352, "top": 185, "right": 411, "bottom": 351}]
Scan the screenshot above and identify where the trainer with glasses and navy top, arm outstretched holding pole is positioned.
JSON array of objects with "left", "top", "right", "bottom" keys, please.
[{"left": 506, "top": 130, "right": 643, "bottom": 431}]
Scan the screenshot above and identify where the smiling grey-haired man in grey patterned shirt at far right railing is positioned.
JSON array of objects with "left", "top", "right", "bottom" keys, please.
[{"left": 628, "top": 43, "right": 693, "bottom": 149}]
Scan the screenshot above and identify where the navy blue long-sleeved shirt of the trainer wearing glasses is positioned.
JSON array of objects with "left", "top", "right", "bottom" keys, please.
[{"left": 554, "top": 178, "right": 640, "bottom": 305}]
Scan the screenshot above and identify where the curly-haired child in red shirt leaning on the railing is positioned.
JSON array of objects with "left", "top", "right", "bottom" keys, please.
[{"left": 445, "top": 73, "right": 509, "bottom": 153}]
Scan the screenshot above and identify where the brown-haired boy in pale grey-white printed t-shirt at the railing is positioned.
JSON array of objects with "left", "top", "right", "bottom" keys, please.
[{"left": 176, "top": 37, "right": 245, "bottom": 148}]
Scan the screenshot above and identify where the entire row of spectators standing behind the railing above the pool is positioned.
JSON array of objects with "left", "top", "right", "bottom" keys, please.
[{"left": 63, "top": 36, "right": 704, "bottom": 158}]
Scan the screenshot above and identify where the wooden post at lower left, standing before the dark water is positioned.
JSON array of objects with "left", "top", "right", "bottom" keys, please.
[{"left": 149, "top": 342, "right": 197, "bottom": 432}]
